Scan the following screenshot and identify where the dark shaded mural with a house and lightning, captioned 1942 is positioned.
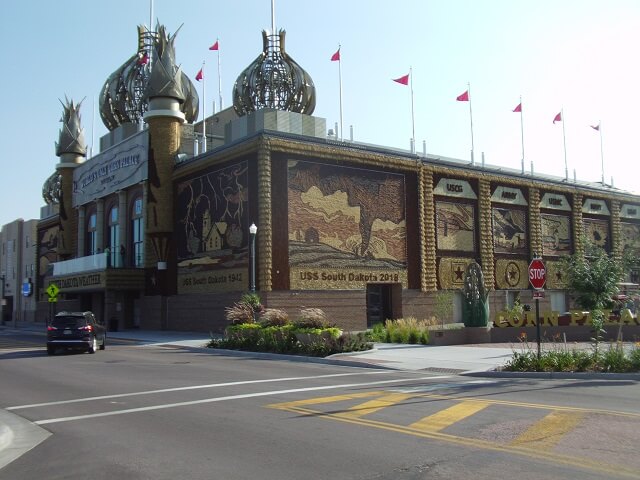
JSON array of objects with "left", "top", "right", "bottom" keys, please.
[{"left": 175, "top": 162, "right": 249, "bottom": 293}]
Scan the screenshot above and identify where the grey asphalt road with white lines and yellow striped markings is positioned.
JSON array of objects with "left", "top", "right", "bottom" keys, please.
[{"left": 0, "top": 336, "right": 640, "bottom": 480}]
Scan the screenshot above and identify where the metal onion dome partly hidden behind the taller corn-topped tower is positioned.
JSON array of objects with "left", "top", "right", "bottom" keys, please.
[{"left": 100, "top": 25, "right": 198, "bottom": 130}]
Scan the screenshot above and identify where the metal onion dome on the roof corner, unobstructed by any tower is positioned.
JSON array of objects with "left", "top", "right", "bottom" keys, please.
[{"left": 233, "top": 30, "right": 316, "bottom": 116}]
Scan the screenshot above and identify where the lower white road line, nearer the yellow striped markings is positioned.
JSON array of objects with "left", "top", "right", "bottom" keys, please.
[{"left": 33, "top": 375, "right": 452, "bottom": 425}]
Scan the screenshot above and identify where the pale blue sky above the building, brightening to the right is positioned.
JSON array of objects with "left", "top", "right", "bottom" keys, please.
[{"left": 0, "top": 0, "right": 640, "bottom": 225}]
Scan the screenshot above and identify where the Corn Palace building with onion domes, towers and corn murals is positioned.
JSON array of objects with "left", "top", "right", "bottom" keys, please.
[{"left": 37, "top": 21, "right": 640, "bottom": 338}]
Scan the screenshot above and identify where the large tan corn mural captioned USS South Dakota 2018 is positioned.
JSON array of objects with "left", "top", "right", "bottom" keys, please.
[{"left": 288, "top": 160, "right": 407, "bottom": 288}]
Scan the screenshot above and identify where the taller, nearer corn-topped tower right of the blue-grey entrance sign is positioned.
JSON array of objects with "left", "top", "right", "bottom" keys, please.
[{"left": 143, "top": 26, "right": 185, "bottom": 295}]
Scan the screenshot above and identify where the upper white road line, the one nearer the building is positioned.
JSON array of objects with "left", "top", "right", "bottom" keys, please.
[{"left": 5, "top": 370, "right": 398, "bottom": 410}]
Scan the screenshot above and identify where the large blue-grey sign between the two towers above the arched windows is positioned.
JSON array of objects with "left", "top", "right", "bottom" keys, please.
[{"left": 72, "top": 130, "right": 149, "bottom": 207}]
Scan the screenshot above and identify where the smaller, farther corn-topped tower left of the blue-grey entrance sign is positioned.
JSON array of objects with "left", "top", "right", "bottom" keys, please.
[{"left": 52, "top": 98, "right": 87, "bottom": 260}]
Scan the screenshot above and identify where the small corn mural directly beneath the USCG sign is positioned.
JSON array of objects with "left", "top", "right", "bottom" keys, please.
[{"left": 436, "top": 202, "right": 476, "bottom": 252}]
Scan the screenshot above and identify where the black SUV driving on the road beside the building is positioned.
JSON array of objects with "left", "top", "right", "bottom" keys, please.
[{"left": 47, "top": 312, "right": 107, "bottom": 355}]
